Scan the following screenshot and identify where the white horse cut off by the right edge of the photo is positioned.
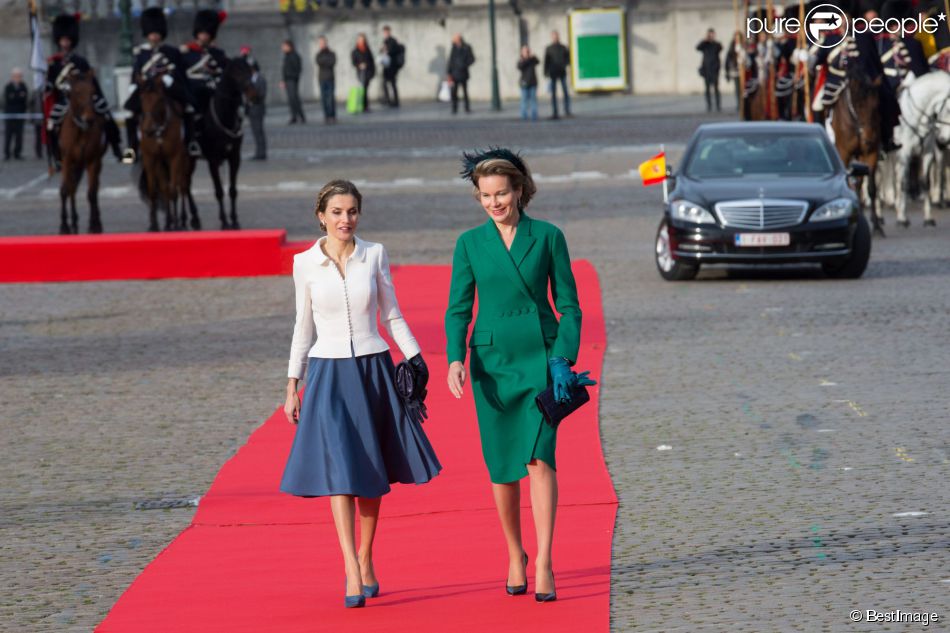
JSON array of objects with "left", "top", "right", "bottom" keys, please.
[{"left": 894, "top": 70, "right": 950, "bottom": 227}]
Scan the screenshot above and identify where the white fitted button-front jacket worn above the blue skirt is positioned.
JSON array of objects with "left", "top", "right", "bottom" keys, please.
[{"left": 287, "top": 237, "right": 420, "bottom": 378}]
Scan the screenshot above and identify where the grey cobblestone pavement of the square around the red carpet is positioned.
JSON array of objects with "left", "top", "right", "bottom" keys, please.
[{"left": 0, "top": 96, "right": 950, "bottom": 633}]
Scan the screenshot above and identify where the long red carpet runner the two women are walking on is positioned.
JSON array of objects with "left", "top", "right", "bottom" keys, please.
[{"left": 96, "top": 262, "right": 617, "bottom": 633}]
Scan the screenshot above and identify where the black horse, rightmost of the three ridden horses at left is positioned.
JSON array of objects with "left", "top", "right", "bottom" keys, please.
[{"left": 187, "top": 57, "right": 257, "bottom": 229}]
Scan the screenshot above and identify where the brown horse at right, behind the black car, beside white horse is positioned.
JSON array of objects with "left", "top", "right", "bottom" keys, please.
[{"left": 831, "top": 66, "right": 884, "bottom": 237}]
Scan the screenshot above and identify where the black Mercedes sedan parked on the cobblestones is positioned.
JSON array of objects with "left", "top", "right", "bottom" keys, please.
[{"left": 656, "top": 121, "right": 871, "bottom": 281}]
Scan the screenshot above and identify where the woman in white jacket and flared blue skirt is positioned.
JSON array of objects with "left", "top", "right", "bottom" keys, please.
[{"left": 280, "top": 180, "right": 442, "bottom": 608}]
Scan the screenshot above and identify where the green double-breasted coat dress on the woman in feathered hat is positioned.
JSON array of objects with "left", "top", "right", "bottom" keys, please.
[{"left": 445, "top": 214, "right": 581, "bottom": 483}]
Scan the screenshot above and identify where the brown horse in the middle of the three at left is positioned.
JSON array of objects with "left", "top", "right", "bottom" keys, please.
[{"left": 139, "top": 75, "right": 201, "bottom": 231}]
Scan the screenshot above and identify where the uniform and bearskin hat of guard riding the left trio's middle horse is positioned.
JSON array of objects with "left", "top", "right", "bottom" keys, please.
[{"left": 123, "top": 7, "right": 201, "bottom": 163}]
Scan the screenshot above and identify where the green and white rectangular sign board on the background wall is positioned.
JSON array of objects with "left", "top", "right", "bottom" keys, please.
[{"left": 569, "top": 9, "right": 627, "bottom": 92}]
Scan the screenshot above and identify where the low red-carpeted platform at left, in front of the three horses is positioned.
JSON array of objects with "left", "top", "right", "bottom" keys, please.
[{"left": 0, "top": 229, "right": 310, "bottom": 283}]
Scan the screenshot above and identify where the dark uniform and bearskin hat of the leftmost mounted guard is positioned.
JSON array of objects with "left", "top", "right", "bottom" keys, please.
[{"left": 43, "top": 14, "right": 122, "bottom": 168}]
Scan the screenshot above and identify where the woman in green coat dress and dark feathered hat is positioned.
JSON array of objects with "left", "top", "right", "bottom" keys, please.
[{"left": 445, "top": 148, "right": 595, "bottom": 602}]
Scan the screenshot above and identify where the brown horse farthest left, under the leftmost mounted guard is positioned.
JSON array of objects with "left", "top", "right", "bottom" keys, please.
[{"left": 59, "top": 70, "right": 108, "bottom": 234}]
